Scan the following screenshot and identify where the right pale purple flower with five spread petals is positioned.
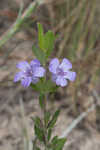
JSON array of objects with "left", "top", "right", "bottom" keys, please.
[{"left": 49, "top": 58, "right": 76, "bottom": 87}]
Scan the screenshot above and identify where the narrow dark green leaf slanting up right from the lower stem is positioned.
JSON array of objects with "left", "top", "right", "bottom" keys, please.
[{"left": 48, "top": 110, "right": 60, "bottom": 128}]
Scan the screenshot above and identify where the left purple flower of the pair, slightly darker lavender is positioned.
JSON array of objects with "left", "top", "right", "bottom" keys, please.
[{"left": 14, "top": 59, "right": 45, "bottom": 88}]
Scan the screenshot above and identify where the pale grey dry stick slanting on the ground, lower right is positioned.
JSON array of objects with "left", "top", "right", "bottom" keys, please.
[{"left": 60, "top": 105, "right": 96, "bottom": 138}]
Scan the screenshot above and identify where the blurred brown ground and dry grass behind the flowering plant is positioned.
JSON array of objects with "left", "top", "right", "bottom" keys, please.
[{"left": 0, "top": 0, "right": 100, "bottom": 150}]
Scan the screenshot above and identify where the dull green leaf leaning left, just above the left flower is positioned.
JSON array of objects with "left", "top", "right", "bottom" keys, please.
[{"left": 32, "top": 45, "right": 46, "bottom": 65}]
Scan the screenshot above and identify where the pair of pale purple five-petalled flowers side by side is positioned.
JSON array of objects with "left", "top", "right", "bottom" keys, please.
[{"left": 14, "top": 58, "right": 76, "bottom": 87}]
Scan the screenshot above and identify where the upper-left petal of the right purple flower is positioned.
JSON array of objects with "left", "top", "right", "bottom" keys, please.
[{"left": 49, "top": 58, "right": 59, "bottom": 74}]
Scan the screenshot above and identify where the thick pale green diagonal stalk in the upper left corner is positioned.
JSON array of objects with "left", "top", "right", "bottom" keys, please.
[{"left": 0, "top": 0, "right": 41, "bottom": 47}]
